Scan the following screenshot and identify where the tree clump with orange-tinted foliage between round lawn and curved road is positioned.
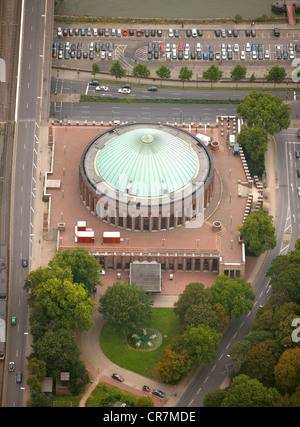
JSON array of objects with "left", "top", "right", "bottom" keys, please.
[{"left": 157, "top": 274, "right": 255, "bottom": 384}]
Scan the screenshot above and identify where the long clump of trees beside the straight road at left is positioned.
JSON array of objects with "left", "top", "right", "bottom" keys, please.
[{"left": 24, "top": 248, "right": 101, "bottom": 407}]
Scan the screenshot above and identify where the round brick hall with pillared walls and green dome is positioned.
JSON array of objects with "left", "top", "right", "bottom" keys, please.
[{"left": 79, "top": 124, "right": 214, "bottom": 232}]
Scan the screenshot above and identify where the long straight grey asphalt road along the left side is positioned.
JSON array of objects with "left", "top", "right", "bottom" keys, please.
[{"left": 3, "top": 0, "right": 46, "bottom": 407}]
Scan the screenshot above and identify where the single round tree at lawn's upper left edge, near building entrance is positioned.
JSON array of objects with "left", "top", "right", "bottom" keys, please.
[{"left": 98, "top": 282, "right": 153, "bottom": 332}]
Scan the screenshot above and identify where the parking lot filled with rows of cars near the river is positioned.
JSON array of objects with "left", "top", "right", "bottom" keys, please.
[{"left": 52, "top": 26, "right": 300, "bottom": 77}]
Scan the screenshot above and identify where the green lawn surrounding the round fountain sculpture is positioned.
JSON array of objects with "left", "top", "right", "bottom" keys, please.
[{"left": 100, "top": 308, "right": 180, "bottom": 380}]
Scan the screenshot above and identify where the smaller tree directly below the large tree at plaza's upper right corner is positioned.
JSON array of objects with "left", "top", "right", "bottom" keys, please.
[{"left": 237, "top": 126, "right": 268, "bottom": 161}]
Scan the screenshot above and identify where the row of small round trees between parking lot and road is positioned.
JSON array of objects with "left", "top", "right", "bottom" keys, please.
[{"left": 92, "top": 61, "right": 287, "bottom": 87}]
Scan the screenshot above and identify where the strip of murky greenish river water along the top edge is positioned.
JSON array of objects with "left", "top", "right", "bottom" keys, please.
[{"left": 55, "top": 0, "right": 272, "bottom": 19}]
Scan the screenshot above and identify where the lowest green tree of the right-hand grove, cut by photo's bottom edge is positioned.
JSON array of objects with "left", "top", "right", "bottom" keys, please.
[{"left": 221, "top": 374, "right": 279, "bottom": 408}]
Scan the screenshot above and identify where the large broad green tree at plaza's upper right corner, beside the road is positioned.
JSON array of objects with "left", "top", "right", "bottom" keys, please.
[{"left": 236, "top": 90, "right": 291, "bottom": 135}]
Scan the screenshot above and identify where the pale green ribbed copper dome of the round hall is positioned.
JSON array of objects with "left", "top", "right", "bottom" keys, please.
[{"left": 95, "top": 128, "right": 198, "bottom": 197}]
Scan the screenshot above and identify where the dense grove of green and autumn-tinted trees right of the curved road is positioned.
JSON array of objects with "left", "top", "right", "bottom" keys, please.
[{"left": 204, "top": 239, "right": 300, "bottom": 407}]
